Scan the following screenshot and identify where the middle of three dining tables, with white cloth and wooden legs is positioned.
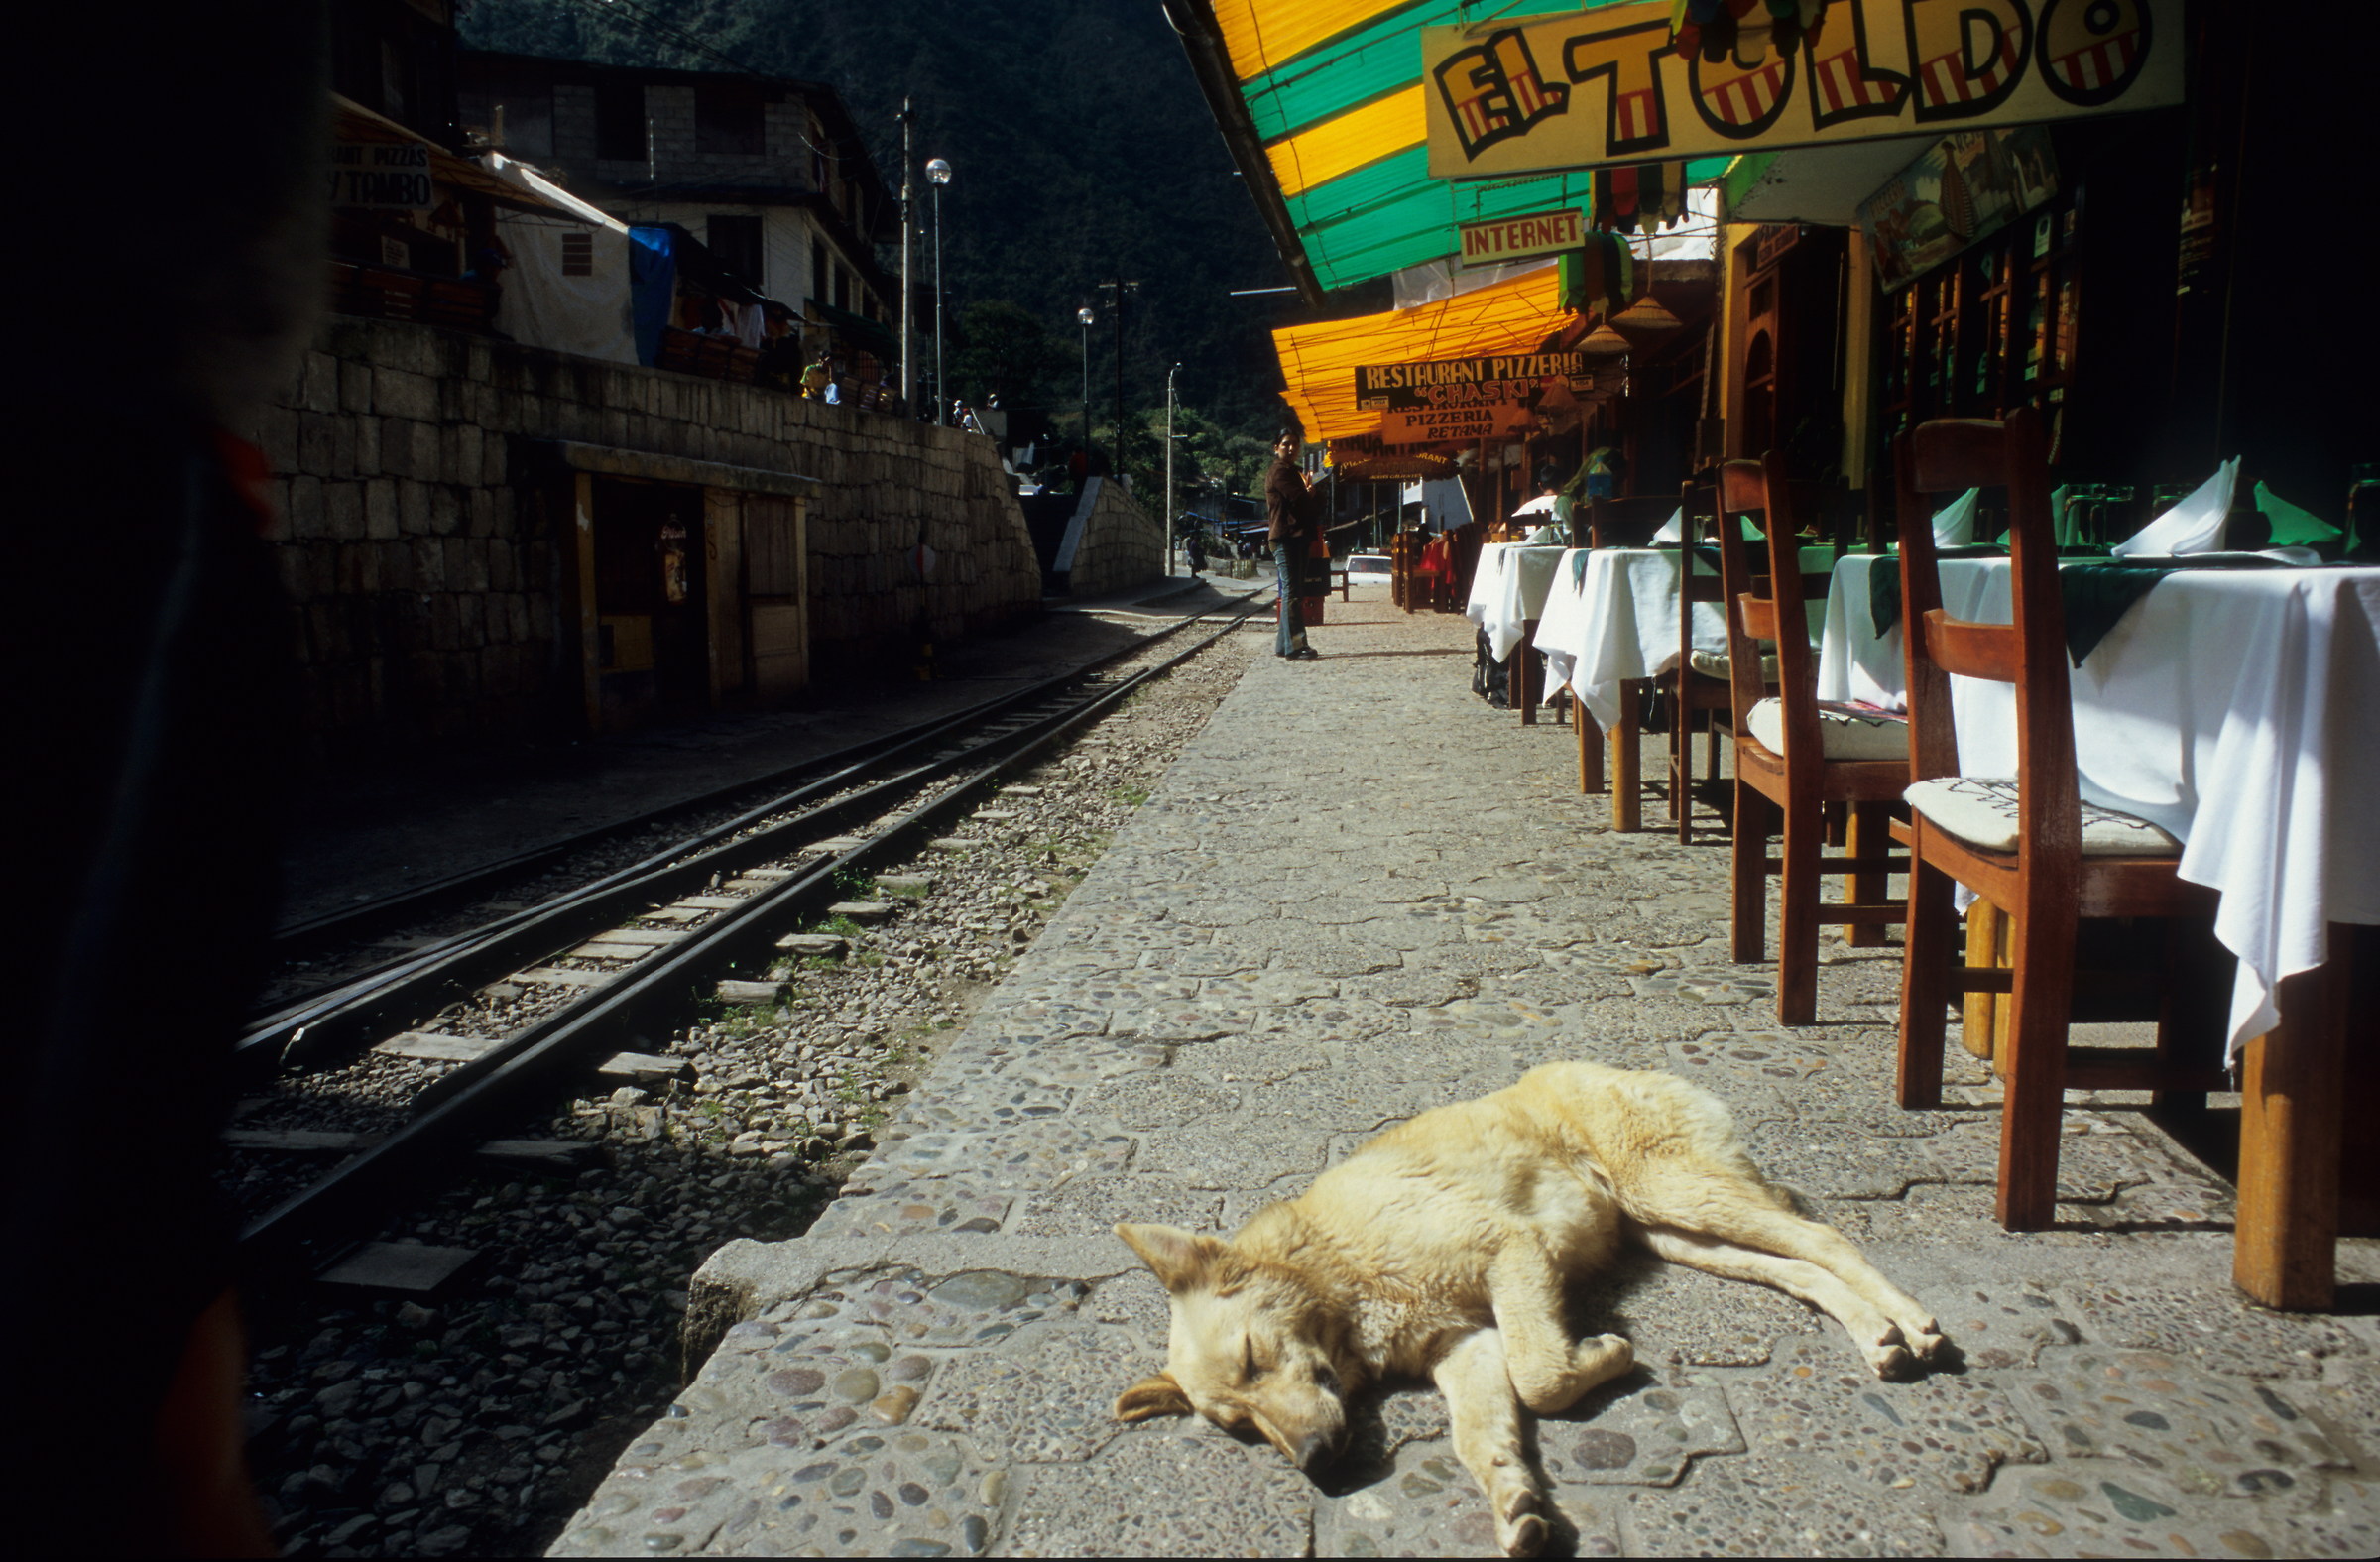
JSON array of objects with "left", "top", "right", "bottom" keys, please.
[{"left": 1535, "top": 542, "right": 1835, "bottom": 831}]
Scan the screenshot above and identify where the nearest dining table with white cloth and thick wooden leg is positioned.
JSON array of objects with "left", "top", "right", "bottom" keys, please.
[{"left": 1819, "top": 554, "right": 2380, "bottom": 1307}]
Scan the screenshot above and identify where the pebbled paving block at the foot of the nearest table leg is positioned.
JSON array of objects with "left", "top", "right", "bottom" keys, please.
[{"left": 2057, "top": 1283, "right": 2370, "bottom": 1379}]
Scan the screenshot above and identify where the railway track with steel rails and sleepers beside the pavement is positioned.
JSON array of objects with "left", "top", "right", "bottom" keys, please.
[{"left": 228, "top": 600, "right": 1268, "bottom": 1271}]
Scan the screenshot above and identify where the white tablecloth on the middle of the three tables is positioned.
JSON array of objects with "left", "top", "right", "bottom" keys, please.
[{"left": 1537, "top": 547, "right": 1835, "bottom": 731}]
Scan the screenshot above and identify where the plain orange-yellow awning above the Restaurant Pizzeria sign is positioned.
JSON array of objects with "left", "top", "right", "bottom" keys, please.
[{"left": 1273, "top": 267, "right": 1571, "bottom": 440}]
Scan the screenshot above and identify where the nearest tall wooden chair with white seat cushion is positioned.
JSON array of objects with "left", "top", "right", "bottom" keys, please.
[{"left": 1894, "top": 410, "right": 2223, "bottom": 1231}]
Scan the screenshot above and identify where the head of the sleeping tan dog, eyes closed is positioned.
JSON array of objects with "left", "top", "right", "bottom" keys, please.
[{"left": 1117, "top": 1226, "right": 1357, "bottom": 1469}]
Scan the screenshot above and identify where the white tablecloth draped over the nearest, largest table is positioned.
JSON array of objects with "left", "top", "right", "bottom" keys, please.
[{"left": 1819, "top": 557, "right": 2380, "bottom": 1050}]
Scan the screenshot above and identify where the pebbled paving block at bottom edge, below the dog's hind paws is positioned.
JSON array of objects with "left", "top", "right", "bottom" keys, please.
[{"left": 1628, "top": 1453, "right": 1942, "bottom": 1557}]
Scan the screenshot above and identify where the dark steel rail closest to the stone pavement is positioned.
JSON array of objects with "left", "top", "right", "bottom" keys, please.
[{"left": 238, "top": 605, "right": 1261, "bottom": 1264}]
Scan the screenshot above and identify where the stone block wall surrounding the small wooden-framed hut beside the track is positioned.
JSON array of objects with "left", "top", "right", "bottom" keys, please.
[{"left": 252, "top": 316, "right": 1040, "bottom": 750}]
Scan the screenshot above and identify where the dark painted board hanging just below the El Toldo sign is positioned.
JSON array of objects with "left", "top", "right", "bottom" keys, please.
[{"left": 1858, "top": 124, "right": 2059, "bottom": 291}]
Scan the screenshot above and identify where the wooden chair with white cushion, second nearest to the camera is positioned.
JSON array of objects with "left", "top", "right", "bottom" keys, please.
[{"left": 1719, "top": 452, "right": 1909, "bottom": 1023}]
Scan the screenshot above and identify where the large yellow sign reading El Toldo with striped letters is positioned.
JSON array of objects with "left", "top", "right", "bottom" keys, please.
[{"left": 1421, "top": 0, "right": 2183, "bottom": 179}]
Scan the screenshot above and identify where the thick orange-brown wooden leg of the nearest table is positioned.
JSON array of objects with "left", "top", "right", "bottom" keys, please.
[{"left": 2232, "top": 924, "right": 2354, "bottom": 1312}]
